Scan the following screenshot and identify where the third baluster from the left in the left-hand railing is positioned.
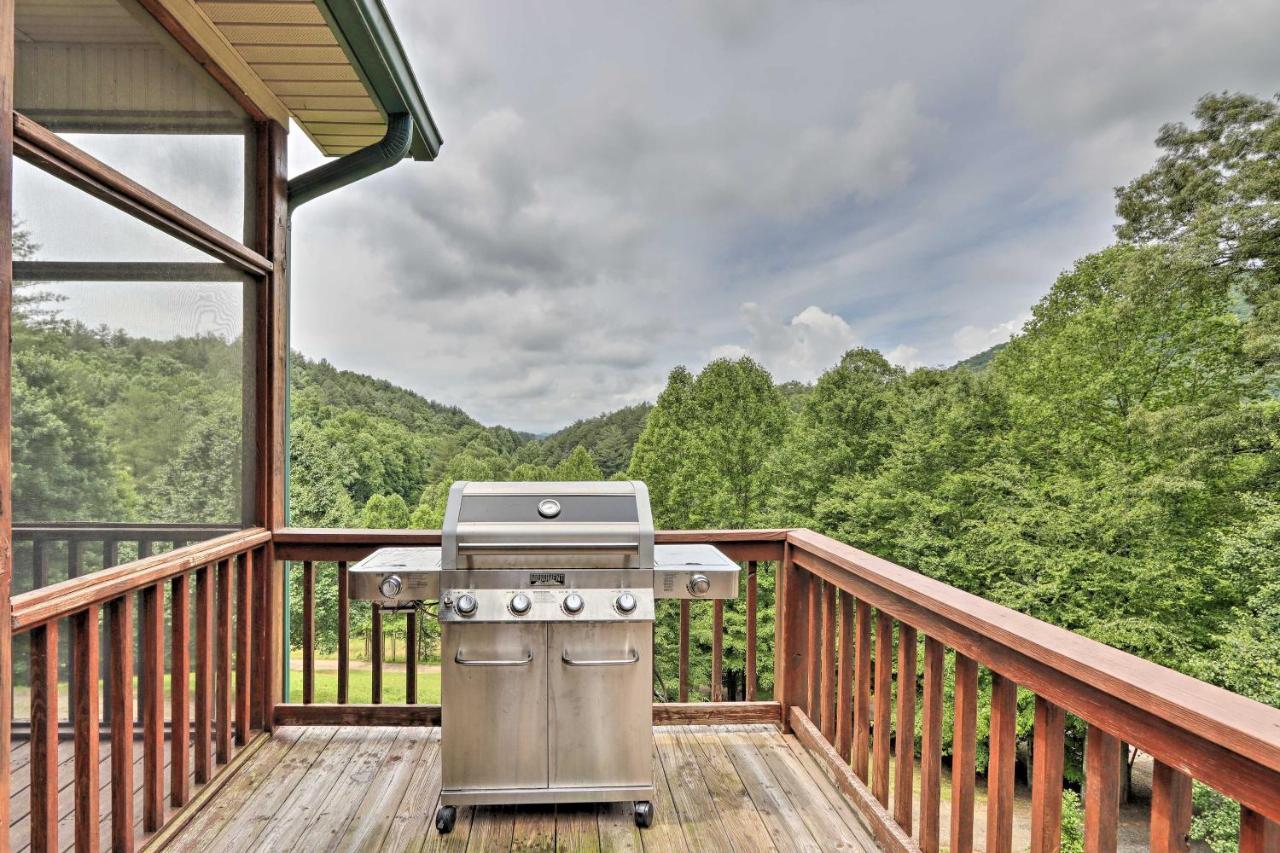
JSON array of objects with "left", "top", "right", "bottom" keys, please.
[{"left": 106, "top": 594, "right": 133, "bottom": 850}]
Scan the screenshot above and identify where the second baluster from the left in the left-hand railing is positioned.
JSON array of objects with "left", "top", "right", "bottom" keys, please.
[{"left": 68, "top": 605, "right": 101, "bottom": 853}]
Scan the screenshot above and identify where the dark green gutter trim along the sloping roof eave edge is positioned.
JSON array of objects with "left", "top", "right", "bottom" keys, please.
[{"left": 316, "top": 0, "right": 444, "bottom": 160}]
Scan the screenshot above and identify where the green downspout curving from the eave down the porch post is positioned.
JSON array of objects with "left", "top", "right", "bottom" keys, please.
[{"left": 282, "top": 113, "right": 413, "bottom": 702}]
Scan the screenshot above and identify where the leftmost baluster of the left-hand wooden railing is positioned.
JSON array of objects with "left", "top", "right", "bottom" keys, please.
[{"left": 29, "top": 621, "right": 61, "bottom": 853}]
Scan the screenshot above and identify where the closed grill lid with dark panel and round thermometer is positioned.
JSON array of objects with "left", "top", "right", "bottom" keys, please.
[{"left": 442, "top": 480, "right": 653, "bottom": 571}]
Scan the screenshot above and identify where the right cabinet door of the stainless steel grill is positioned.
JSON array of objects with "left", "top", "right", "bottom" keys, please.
[{"left": 547, "top": 622, "right": 653, "bottom": 788}]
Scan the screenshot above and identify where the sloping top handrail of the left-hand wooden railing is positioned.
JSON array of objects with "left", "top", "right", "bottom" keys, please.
[{"left": 12, "top": 528, "right": 271, "bottom": 634}]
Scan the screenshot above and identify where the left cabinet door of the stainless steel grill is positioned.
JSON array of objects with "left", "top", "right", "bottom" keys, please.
[{"left": 440, "top": 622, "right": 547, "bottom": 790}]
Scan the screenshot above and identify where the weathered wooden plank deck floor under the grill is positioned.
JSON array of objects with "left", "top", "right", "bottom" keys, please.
[{"left": 149, "top": 726, "right": 878, "bottom": 852}]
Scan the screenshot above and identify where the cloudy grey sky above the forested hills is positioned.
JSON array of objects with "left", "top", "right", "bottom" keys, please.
[{"left": 18, "top": 0, "right": 1280, "bottom": 432}]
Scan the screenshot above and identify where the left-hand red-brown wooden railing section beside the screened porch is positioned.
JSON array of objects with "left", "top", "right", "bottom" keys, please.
[{"left": 9, "top": 529, "right": 271, "bottom": 850}]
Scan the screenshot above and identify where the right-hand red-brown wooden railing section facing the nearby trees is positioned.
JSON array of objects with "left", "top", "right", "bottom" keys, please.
[{"left": 777, "top": 530, "right": 1280, "bottom": 853}]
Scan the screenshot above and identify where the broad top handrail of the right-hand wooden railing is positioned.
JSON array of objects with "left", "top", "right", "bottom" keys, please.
[{"left": 787, "top": 529, "right": 1280, "bottom": 820}]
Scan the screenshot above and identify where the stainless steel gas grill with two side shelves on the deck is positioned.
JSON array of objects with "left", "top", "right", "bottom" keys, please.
[{"left": 351, "top": 482, "right": 739, "bottom": 833}]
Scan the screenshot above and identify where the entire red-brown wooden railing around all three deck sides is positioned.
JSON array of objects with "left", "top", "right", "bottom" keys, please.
[{"left": 10, "top": 529, "right": 1280, "bottom": 853}]
